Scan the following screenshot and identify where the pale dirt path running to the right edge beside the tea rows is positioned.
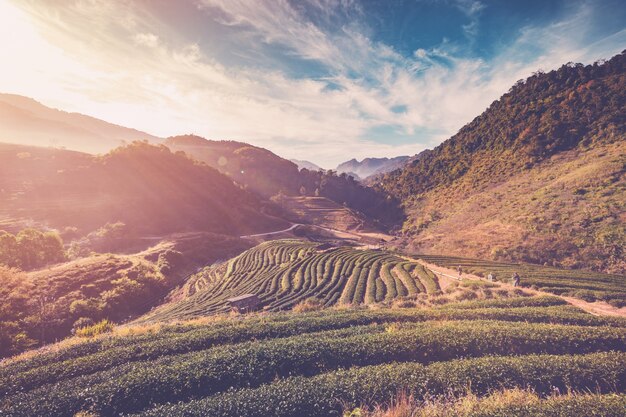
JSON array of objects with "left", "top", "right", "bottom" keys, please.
[{"left": 411, "top": 258, "right": 626, "bottom": 317}]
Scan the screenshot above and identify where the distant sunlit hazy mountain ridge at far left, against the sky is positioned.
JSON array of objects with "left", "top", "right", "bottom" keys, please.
[{"left": 0, "top": 94, "right": 162, "bottom": 153}]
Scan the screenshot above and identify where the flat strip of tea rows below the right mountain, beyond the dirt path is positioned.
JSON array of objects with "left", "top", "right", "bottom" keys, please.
[{"left": 415, "top": 255, "right": 626, "bottom": 308}]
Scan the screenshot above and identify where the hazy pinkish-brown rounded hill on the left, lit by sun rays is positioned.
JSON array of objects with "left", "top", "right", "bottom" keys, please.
[{"left": 0, "top": 142, "right": 287, "bottom": 236}]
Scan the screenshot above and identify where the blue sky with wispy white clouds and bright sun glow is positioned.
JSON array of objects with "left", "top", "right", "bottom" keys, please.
[{"left": 0, "top": 0, "right": 626, "bottom": 168}]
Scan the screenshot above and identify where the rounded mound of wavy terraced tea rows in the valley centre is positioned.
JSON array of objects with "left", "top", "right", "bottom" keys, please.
[{"left": 141, "top": 240, "right": 440, "bottom": 321}]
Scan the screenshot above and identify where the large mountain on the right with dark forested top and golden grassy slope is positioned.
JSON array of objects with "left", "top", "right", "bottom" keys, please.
[{"left": 378, "top": 49, "right": 626, "bottom": 272}]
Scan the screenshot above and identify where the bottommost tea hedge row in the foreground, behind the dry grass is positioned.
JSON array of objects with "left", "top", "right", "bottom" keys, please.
[{"left": 133, "top": 353, "right": 626, "bottom": 417}]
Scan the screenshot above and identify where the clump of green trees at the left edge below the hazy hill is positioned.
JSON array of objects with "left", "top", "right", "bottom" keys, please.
[{"left": 0, "top": 229, "right": 65, "bottom": 270}]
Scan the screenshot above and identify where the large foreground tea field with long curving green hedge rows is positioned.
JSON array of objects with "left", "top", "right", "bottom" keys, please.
[{"left": 0, "top": 294, "right": 626, "bottom": 417}]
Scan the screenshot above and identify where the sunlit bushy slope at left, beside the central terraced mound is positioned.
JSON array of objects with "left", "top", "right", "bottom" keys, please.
[{"left": 0, "top": 233, "right": 251, "bottom": 358}]
